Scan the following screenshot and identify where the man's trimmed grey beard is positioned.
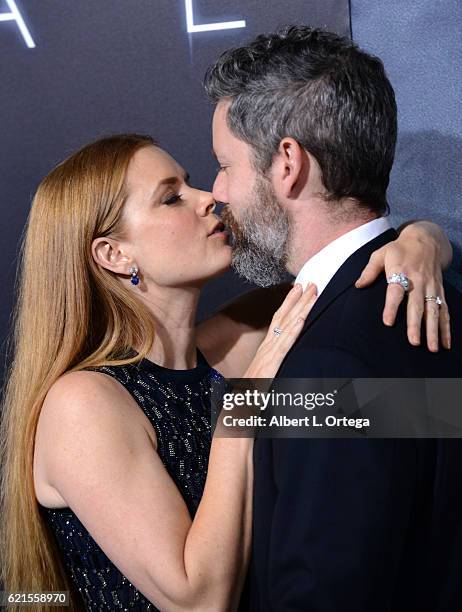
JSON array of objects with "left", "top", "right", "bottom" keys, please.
[{"left": 222, "top": 177, "right": 290, "bottom": 287}]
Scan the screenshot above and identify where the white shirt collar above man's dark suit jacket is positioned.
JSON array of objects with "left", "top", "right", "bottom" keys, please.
[{"left": 295, "top": 217, "right": 391, "bottom": 296}]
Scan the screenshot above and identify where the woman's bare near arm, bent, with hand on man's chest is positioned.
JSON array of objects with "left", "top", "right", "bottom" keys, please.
[{"left": 36, "top": 289, "right": 315, "bottom": 612}]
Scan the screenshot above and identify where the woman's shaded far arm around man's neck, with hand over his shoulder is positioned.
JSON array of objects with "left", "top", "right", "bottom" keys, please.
[{"left": 197, "top": 221, "right": 452, "bottom": 378}]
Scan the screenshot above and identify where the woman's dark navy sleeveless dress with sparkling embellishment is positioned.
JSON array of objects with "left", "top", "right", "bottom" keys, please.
[{"left": 40, "top": 351, "right": 224, "bottom": 612}]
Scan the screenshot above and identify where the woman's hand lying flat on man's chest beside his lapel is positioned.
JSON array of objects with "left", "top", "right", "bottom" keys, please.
[{"left": 244, "top": 283, "right": 317, "bottom": 379}]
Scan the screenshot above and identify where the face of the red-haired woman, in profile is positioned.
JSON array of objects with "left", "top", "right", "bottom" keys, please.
[{"left": 122, "top": 147, "right": 231, "bottom": 286}]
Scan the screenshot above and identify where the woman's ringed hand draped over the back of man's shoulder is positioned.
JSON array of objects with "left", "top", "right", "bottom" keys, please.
[{"left": 356, "top": 221, "right": 452, "bottom": 352}]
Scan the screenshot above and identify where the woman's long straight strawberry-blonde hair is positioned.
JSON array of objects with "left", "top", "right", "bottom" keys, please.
[{"left": 0, "top": 134, "right": 155, "bottom": 612}]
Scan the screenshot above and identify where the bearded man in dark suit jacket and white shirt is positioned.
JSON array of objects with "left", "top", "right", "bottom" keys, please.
[{"left": 206, "top": 27, "right": 462, "bottom": 612}]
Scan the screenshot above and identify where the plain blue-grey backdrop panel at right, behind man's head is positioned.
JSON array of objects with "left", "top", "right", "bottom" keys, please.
[{"left": 350, "top": 0, "right": 462, "bottom": 291}]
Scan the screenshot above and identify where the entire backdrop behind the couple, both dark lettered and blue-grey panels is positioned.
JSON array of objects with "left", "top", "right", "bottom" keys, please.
[{"left": 0, "top": 0, "right": 462, "bottom": 382}]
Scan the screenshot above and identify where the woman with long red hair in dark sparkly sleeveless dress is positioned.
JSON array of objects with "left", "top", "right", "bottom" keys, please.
[{"left": 2, "top": 135, "right": 452, "bottom": 611}]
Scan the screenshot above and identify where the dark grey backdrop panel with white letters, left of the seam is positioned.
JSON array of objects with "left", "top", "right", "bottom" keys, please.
[{"left": 0, "top": 0, "right": 350, "bottom": 372}]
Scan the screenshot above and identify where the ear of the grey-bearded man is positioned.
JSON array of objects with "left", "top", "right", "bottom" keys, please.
[{"left": 272, "top": 137, "right": 310, "bottom": 199}]
